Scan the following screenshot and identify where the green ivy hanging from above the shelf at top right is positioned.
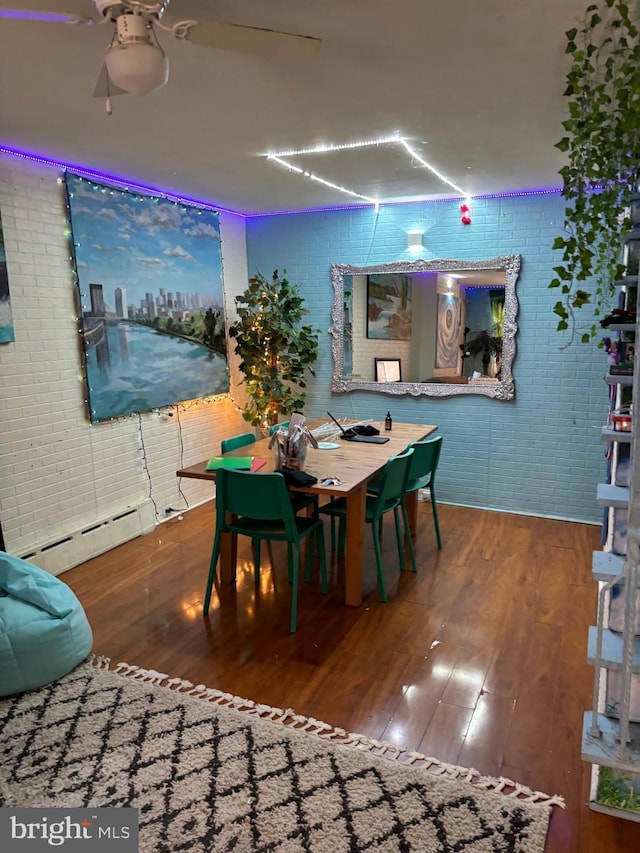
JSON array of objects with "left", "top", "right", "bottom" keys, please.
[{"left": 549, "top": 0, "right": 640, "bottom": 343}]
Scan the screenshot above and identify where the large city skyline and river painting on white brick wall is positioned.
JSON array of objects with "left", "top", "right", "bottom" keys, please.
[{"left": 66, "top": 173, "right": 229, "bottom": 421}]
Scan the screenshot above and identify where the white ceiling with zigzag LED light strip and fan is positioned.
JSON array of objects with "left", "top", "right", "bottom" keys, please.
[{"left": 0, "top": 0, "right": 587, "bottom": 213}]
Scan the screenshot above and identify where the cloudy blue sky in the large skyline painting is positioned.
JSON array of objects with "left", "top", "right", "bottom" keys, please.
[{"left": 66, "top": 173, "right": 223, "bottom": 311}]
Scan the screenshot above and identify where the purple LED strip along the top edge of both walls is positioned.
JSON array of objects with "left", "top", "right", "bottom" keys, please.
[{"left": 0, "top": 145, "right": 562, "bottom": 219}]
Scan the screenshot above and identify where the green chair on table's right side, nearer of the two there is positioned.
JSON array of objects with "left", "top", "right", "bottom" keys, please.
[{"left": 318, "top": 448, "right": 416, "bottom": 601}]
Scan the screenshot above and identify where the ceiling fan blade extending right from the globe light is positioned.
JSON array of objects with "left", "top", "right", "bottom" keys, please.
[{"left": 179, "top": 21, "right": 321, "bottom": 59}]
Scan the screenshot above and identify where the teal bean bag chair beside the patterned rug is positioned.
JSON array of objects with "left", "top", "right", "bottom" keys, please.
[{"left": 0, "top": 551, "right": 93, "bottom": 696}]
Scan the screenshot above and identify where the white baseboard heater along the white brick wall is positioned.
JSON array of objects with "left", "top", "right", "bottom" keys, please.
[{"left": 18, "top": 501, "right": 156, "bottom": 575}]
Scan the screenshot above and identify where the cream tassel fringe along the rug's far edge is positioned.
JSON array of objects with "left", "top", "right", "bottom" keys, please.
[{"left": 87, "top": 655, "right": 565, "bottom": 808}]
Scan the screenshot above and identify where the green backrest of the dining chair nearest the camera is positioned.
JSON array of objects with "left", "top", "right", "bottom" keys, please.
[{"left": 216, "top": 468, "right": 298, "bottom": 541}]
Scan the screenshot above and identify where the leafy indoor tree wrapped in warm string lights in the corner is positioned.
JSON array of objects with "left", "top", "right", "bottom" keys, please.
[{"left": 229, "top": 270, "right": 320, "bottom": 429}]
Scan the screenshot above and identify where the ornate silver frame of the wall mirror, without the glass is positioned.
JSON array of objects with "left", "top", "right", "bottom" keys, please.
[{"left": 329, "top": 255, "right": 520, "bottom": 400}]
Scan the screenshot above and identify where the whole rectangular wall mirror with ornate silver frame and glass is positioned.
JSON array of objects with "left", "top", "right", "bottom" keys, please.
[{"left": 329, "top": 255, "right": 520, "bottom": 400}]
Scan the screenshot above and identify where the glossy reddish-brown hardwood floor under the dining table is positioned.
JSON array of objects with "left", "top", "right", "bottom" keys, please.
[{"left": 62, "top": 503, "right": 640, "bottom": 853}]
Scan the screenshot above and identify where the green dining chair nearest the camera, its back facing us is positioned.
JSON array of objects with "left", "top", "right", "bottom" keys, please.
[{"left": 203, "top": 468, "right": 327, "bottom": 634}]
